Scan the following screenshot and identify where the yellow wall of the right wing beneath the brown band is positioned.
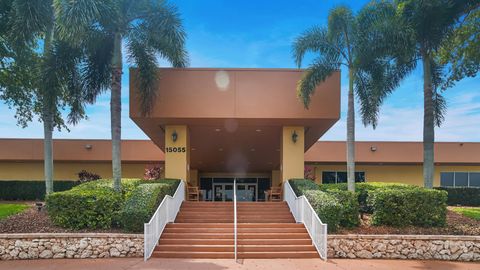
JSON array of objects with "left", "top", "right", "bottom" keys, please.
[{"left": 312, "top": 165, "right": 480, "bottom": 186}]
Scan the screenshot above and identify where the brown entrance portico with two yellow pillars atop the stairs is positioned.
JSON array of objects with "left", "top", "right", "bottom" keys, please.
[{"left": 130, "top": 68, "right": 340, "bottom": 198}]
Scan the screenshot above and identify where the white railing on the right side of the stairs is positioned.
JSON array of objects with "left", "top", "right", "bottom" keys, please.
[{"left": 283, "top": 181, "right": 327, "bottom": 260}]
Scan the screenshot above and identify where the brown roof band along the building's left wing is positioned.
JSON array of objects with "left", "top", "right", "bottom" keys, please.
[{"left": 0, "top": 139, "right": 164, "bottom": 162}]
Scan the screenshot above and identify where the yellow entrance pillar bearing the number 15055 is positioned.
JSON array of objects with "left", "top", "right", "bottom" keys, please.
[{"left": 165, "top": 126, "right": 190, "bottom": 181}]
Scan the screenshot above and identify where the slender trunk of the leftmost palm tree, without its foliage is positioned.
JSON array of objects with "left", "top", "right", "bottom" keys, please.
[{"left": 41, "top": 15, "right": 55, "bottom": 194}]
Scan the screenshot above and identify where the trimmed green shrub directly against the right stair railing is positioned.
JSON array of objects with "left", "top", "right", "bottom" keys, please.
[{"left": 304, "top": 190, "right": 343, "bottom": 232}]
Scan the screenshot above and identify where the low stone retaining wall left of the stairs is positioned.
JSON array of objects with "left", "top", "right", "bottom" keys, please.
[{"left": 0, "top": 233, "right": 143, "bottom": 260}]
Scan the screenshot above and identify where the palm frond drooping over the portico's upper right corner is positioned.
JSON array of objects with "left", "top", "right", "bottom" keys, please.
[{"left": 297, "top": 54, "right": 341, "bottom": 109}]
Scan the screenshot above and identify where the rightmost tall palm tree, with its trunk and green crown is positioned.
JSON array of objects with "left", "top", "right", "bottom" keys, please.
[{"left": 356, "top": 0, "right": 479, "bottom": 188}]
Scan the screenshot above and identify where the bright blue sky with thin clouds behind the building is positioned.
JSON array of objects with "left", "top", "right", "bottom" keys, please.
[{"left": 0, "top": 0, "right": 480, "bottom": 141}]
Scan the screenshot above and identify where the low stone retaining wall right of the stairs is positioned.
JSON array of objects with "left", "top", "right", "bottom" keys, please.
[{"left": 328, "top": 235, "right": 480, "bottom": 261}]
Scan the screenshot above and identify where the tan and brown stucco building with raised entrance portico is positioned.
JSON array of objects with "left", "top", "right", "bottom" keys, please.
[{"left": 0, "top": 69, "right": 480, "bottom": 200}]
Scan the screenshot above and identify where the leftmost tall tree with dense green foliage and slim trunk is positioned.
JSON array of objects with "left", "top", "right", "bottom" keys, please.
[{"left": 0, "top": 0, "right": 85, "bottom": 194}]
